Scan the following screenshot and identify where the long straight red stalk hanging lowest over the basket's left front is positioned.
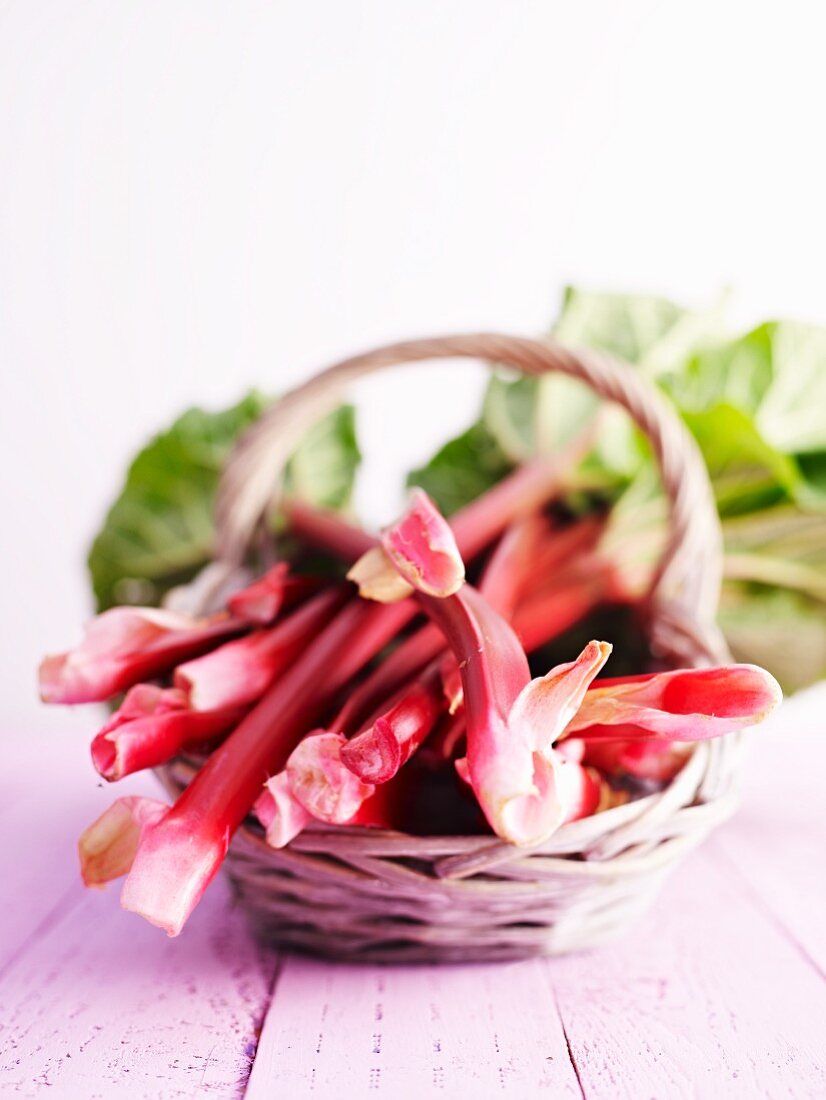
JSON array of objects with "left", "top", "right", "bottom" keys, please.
[{"left": 121, "top": 600, "right": 409, "bottom": 935}]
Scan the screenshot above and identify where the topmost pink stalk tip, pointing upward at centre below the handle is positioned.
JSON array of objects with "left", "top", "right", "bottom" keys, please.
[{"left": 382, "top": 488, "right": 464, "bottom": 597}]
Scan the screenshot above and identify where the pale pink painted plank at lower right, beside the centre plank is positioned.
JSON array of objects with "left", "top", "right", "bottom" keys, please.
[{"left": 547, "top": 851, "right": 826, "bottom": 1100}]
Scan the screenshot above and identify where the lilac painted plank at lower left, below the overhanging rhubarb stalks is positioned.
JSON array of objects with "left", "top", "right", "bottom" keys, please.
[{"left": 0, "top": 879, "right": 275, "bottom": 1100}]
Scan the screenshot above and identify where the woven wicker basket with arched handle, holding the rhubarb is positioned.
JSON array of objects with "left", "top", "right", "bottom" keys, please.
[{"left": 162, "top": 334, "right": 740, "bottom": 961}]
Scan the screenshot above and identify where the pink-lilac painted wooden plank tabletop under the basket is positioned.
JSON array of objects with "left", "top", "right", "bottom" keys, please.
[{"left": 0, "top": 689, "right": 826, "bottom": 1100}]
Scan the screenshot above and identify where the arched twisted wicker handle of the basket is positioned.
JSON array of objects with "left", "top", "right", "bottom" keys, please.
[{"left": 216, "top": 333, "right": 727, "bottom": 663}]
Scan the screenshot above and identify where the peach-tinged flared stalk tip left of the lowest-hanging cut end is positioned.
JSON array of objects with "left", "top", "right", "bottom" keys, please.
[{"left": 78, "top": 795, "right": 169, "bottom": 887}]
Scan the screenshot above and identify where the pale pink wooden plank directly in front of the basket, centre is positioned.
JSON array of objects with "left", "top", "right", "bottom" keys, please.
[{"left": 247, "top": 958, "right": 582, "bottom": 1100}]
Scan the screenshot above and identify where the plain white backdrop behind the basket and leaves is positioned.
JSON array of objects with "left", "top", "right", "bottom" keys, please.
[{"left": 0, "top": 0, "right": 826, "bottom": 733}]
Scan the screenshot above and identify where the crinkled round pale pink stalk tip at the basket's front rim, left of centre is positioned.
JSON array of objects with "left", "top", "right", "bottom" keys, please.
[{"left": 287, "top": 730, "right": 375, "bottom": 825}]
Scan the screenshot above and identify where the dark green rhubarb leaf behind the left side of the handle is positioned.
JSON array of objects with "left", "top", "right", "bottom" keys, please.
[{"left": 88, "top": 392, "right": 360, "bottom": 611}]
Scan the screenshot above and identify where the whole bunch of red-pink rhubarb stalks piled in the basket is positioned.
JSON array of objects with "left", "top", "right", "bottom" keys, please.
[{"left": 40, "top": 460, "right": 780, "bottom": 935}]
